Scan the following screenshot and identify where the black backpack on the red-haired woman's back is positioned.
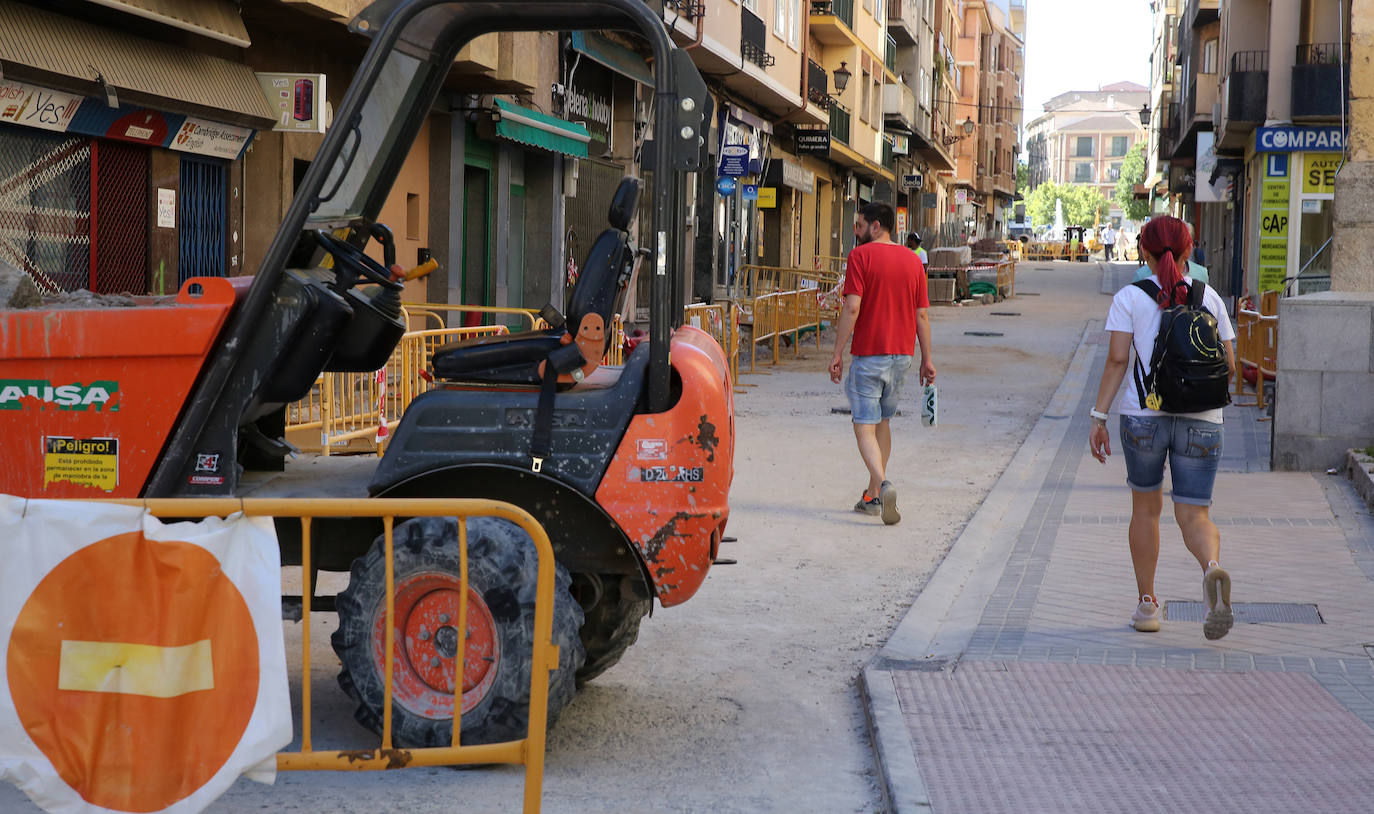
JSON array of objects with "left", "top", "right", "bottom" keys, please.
[{"left": 1135, "top": 279, "right": 1231, "bottom": 413}]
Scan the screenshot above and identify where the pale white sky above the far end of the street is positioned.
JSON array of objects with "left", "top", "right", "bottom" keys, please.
[{"left": 1022, "top": 0, "right": 1153, "bottom": 122}]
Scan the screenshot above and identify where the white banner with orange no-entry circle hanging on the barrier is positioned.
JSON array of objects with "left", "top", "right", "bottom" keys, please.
[{"left": 0, "top": 496, "right": 291, "bottom": 814}]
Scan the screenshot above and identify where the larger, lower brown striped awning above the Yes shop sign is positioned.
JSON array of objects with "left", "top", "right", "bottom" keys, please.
[{"left": 0, "top": 0, "right": 275, "bottom": 129}]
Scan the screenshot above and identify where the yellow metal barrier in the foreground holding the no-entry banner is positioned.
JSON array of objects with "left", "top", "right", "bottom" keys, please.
[{"left": 96, "top": 498, "right": 558, "bottom": 814}]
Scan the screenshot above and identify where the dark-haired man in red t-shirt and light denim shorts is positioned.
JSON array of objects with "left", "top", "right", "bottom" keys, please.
[{"left": 830, "top": 204, "right": 936, "bottom": 525}]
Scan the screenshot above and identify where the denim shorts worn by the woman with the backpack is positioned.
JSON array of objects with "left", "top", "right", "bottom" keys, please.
[{"left": 1121, "top": 415, "right": 1221, "bottom": 506}]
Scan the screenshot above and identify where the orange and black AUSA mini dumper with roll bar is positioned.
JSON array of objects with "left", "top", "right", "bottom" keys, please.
[{"left": 0, "top": 0, "right": 734, "bottom": 747}]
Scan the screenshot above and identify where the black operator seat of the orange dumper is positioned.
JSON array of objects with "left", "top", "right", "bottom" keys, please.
[{"left": 431, "top": 177, "right": 640, "bottom": 385}]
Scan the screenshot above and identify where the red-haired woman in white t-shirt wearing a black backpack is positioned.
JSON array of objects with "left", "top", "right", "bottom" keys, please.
[{"left": 1088, "top": 216, "right": 1235, "bottom": 639}]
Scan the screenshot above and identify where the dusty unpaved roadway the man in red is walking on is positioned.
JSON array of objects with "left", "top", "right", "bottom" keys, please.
[{"left": 0, "top": 264, "right": 1107, "bottom": 814}]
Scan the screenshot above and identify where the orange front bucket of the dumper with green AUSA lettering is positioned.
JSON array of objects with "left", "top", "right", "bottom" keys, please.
[{"left": 0, "top": 278, "right": 235, "bottom": 498}]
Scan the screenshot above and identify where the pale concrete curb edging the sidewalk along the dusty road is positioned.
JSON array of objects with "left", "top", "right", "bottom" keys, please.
[{"left": 859, "top": 323, "right": 1101, "bottom": 814}]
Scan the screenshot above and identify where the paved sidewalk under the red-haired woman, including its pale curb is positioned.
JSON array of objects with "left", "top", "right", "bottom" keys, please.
[{"left": 863, "top": 283, "right": 1374, "bottom": 814}]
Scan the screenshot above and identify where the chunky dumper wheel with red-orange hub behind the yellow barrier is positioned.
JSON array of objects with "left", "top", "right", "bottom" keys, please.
[{"left": 333, "top": 517, "right": 585, "bottom": 748}]
